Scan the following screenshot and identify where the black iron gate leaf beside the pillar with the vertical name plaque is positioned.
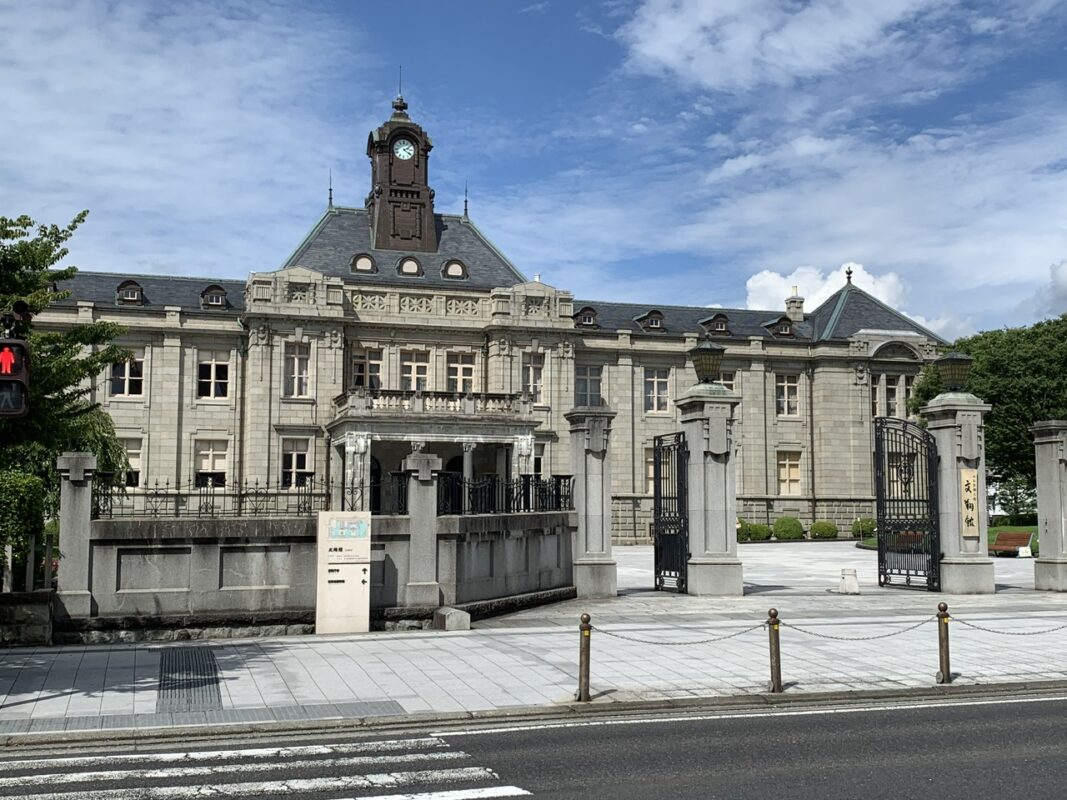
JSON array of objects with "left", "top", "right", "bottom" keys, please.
[{"left": 874, "top": 417, "right": 941, "bottom": 592}]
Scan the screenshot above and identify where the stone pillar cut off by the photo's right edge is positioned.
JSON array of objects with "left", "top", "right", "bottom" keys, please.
[{"left": 1030, "top": 419, "right": 1067, "bottom": 592}]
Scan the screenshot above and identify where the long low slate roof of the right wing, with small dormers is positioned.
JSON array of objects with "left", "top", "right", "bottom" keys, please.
[{"left": 574, "top": 300, "right": 812, "bottom": 340}]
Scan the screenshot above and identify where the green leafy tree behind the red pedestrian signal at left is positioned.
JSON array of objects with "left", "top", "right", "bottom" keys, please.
[{"left": 0, "top": 211, "right": 129, "bottom": 513}]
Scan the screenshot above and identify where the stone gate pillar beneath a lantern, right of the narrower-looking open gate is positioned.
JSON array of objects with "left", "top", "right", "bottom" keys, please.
[{"left": 674, "top": 383, "right": 745, "bottom": 595}]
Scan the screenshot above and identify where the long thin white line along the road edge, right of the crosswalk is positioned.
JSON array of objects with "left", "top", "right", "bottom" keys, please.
[{"left": 434, "top": 695, "right": 1067, "bottom": 739}]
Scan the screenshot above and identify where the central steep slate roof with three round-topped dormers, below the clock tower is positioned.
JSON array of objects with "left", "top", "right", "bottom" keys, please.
[{"left": 283, "top": 207, "right": 526, "bottom": 289}]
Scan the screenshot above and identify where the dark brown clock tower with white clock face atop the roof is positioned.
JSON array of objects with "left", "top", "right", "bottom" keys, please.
[{"left": 366, "top": 95, "right": 437, "bottom": 253}]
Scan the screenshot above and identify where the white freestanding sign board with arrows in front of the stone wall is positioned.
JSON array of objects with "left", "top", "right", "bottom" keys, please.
[{"left": 315, "top": 511, "right": 371, "bottom": 634}]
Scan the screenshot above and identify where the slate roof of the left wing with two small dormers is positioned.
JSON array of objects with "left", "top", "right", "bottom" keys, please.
[{"left": 57, "top": 272, "right": 245, "bottom": 314}]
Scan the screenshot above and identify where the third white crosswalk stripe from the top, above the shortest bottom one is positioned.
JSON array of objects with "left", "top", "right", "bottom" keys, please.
[{"left": 20, "top": 767, "right": 498, "bottom": 800}]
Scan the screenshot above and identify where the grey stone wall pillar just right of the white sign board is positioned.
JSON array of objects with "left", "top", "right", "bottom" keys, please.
[{"left": 401, "top": 452, "right": 441, "bottom": 608}]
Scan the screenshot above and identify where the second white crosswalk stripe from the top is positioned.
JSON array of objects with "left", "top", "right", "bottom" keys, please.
[{"left": 0, "top": 750, "right": 469, "bottom": 789}]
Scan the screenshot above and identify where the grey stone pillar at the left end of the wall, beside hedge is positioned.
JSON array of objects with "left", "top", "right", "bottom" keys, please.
[{"left": 55, "top": 452, "right": 96, "bottom": 619}]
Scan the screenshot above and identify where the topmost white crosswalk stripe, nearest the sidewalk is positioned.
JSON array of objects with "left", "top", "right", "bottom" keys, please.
[{"left": 0, "top": 737, "right": 448, "bottom": 769}]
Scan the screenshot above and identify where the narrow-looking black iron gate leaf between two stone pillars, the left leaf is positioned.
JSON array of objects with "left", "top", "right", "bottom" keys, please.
[{"left": 652, "top": 432, "right": 689, "bottom": 592}]
